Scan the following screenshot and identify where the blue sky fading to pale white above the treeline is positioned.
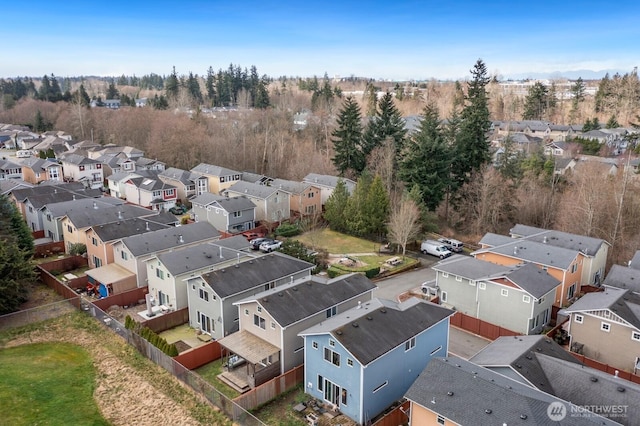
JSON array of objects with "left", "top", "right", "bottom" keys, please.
[{"left": 6, "top": 0, "right": 640, "bottom": 80}]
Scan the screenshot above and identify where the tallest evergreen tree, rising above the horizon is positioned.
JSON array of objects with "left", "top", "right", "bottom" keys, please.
[{"left": 452, "top": 59, "right": 491, "bottom": 187}]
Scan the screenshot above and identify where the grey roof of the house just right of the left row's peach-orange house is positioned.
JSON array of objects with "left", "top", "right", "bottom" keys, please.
[{"left": 122, "top": 222, "right": 220, "bottom": 257}]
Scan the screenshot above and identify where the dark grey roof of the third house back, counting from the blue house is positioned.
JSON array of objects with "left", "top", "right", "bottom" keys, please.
[{"left": 202, "top": 251, "right": 314, "bottom": 298}]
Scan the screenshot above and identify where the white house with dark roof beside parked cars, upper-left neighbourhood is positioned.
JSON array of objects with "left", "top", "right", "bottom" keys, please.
[{"left": 124, "top": 177, "right": 178, "bottom": 210}]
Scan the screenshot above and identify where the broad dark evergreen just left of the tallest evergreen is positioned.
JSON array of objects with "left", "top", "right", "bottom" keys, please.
[{"left": 399, "top": 104, "right": 451, "bottom": 211}]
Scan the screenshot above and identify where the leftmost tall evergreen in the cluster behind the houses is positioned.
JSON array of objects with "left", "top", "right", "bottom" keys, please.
[{"left": 331, "top": 96, "right": 365, "bottom": 176}]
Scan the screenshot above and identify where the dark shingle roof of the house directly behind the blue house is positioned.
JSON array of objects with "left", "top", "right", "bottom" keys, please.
[{"left": 241, "top": 274, "right": 376, "bottom": 327}]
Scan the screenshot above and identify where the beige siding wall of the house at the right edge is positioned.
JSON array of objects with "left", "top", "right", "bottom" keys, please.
[{"left": 569, "top": 312, "right": 640, "bottom": 371}]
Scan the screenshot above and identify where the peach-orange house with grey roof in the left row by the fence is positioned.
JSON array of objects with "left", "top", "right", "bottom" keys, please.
[{"left": 85, "top": 216, "right": 171, "bottom": 268}]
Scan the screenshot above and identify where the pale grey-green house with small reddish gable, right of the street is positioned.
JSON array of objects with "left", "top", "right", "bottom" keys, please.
[{"left": 432, "top": 256, "right": 560, "bottom": 334}]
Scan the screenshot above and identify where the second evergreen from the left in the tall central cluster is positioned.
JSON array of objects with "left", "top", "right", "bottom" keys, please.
[{"left": 364, "top": 92, "right": 407, "bottom": 159}]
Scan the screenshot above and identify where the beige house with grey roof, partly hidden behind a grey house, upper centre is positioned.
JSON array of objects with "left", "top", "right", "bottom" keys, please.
[{"left": 222, "top": 181, "right": 290, "bottom": 222}]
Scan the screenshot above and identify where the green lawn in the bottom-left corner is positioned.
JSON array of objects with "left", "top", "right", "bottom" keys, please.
[{"left": 0, "top": 343, "right": 109, "bottom": 425}]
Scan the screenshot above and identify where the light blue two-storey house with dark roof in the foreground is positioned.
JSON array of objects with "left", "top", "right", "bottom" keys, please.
[{"left": 299, "top": 298, "right": 454, "bottom": 424}]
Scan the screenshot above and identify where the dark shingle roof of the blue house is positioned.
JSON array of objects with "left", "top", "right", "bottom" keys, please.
[{"left": 301, "top": 298, "right": 454, "bottom": 365}]
